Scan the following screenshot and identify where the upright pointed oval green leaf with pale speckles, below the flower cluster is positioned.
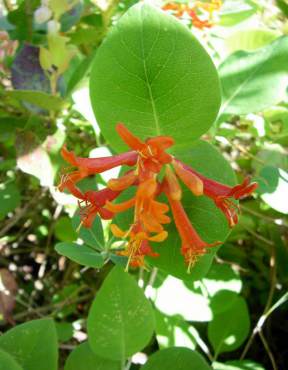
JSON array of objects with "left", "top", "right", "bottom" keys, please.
[{"left": 87, "top": 266, "right": 155, "bottom": 361}]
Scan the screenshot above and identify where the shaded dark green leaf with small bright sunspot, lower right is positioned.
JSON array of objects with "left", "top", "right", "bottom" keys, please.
[{"left": 208, "top": 296, "right": 250, "bottom": 357}]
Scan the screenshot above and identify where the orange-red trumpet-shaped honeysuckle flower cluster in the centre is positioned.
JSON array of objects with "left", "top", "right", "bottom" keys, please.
[{"left": 58, "top": 123, "right": 257, "bottom": 271}]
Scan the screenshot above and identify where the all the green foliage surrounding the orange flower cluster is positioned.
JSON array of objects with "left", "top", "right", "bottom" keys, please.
[{"left": 0, "top": 0, "right": 288, "bottom": 370}]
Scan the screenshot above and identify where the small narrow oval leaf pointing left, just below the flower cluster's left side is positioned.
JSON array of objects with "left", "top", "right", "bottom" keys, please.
[{"left": 55, "top": 242, "right": 104, "bottom": 268}]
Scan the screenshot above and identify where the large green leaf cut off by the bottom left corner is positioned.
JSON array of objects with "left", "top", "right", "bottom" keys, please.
[{"left": 0, "top": 319, "right": 58, "bottom": 370}]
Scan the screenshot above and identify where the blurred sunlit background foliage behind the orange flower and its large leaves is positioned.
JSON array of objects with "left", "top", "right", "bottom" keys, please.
[{"left": 0, "top": 0, "right": 288, "bottom": 370}]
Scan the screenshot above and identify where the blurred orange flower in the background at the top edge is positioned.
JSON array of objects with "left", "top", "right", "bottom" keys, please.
[{"left": 162, "top": 0, "right": 222, "bottom": 30}]
